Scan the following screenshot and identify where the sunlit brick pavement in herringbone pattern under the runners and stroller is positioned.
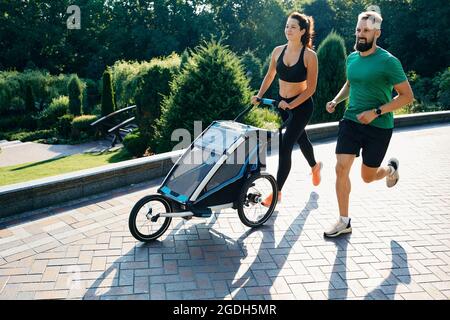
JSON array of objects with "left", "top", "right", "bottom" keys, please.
[{"left": 0, "top": 125, "right": 450, "bottom": 299}]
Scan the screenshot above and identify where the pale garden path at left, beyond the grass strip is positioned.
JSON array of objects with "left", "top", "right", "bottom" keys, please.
[{"left": 0, "top": 140, "right": 111, "bottom": 167}]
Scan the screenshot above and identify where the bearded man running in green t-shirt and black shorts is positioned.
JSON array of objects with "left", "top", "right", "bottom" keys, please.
[{"left": 324, "top": 11, "right": 414, "bottom": 237}]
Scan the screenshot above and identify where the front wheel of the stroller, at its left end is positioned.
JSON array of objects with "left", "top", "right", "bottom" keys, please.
[{"left": 128, "top": 194, "right": 172, "bottom": 242}]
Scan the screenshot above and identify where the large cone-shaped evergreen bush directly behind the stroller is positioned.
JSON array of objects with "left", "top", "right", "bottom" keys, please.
[{"left": 155, "top": 41, "right": 251, "bottom": 152}]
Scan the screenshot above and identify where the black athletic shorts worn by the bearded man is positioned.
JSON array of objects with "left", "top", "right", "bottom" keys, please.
[{"left": 336, "top": 119, "right": 392, "bottom": 168}]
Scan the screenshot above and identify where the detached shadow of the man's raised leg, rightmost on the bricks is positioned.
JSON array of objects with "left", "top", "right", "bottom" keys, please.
[{"left": 364, "top": 240, "right": 411, "bottom": 300}]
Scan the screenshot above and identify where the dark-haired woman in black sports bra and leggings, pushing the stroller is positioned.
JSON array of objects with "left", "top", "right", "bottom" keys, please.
[{"left": 252, "top": 12, "right": 322, "bottom": 206}]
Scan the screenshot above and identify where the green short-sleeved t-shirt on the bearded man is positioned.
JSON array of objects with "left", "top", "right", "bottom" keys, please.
[{"left": 344, "top": 47, "right": 407, "bottom": 129}]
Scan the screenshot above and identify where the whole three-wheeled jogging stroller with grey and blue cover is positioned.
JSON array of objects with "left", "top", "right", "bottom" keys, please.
[{"left": 129, "top": 99, "right": 292, "bottom": 242}]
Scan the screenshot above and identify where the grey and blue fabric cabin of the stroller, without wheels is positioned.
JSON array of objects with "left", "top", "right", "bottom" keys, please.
[{"left": 159, "top": 121, "right": 267, "bottom": 203}]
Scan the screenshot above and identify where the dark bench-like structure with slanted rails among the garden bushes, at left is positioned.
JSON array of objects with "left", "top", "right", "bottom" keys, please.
[{"left": 91, "top": 105, "right": 138, "bottom": 148}]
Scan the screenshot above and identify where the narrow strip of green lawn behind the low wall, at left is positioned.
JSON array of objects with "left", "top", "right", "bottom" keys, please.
[{"left": 0, "top": 149, "right": 132, "bottom": 186}]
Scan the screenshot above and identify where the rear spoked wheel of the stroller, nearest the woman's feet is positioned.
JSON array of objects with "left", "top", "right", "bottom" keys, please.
[{"left": 237, "top": 172, "right": 278, "bottom": 228}]
